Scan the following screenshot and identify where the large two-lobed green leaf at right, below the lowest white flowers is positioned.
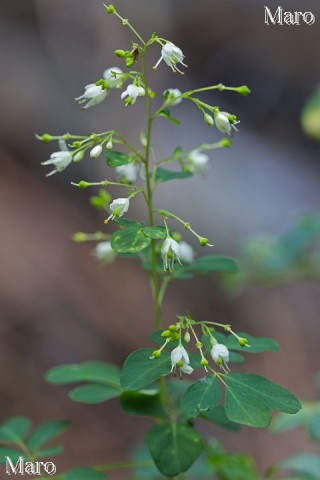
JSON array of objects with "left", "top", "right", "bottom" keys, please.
[{"left": 224, "top": 373, "right": 301, "bottom": 428}]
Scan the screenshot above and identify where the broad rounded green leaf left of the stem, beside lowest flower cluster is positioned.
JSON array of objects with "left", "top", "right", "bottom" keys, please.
[{"left": 120, "top": 348, "right": 171, "bottom": 390}]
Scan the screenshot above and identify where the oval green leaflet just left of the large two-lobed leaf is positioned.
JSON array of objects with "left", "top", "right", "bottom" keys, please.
[{"left": 181, "top": 375, "right": 221, "bottom": 417}]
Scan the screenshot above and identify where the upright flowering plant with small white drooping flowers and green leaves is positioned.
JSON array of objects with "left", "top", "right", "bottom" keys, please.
[{"left": 0, "top": 5, "right": 300, "bottom": 480}]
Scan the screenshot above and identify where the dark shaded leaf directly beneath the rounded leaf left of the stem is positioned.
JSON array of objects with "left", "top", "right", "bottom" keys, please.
[{"left": 120, "top": 390, "right": 165, "bottom": 418}]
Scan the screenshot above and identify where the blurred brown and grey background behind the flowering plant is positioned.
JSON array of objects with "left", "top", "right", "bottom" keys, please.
[{"left": 0, "top": 0, "right": 320, "bottom": 479}]
